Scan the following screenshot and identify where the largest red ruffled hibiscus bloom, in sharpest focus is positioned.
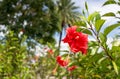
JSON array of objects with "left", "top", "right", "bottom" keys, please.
[{"left": 62, "top": 26, "right": 88, "bottom": 54}]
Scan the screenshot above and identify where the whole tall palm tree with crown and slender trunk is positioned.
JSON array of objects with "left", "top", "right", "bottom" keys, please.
[{"left": 57, "top": 0, "right": 79, "bottom": 54}]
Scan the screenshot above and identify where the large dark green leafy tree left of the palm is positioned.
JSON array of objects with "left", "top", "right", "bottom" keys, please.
[{"left": 0, "top": 0, "right": 59, "bottom": 44}]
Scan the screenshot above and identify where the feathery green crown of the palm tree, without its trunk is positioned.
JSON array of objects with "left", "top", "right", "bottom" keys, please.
[{"left": 57, "top": 0, "right": 80, "bottom": 26}]
